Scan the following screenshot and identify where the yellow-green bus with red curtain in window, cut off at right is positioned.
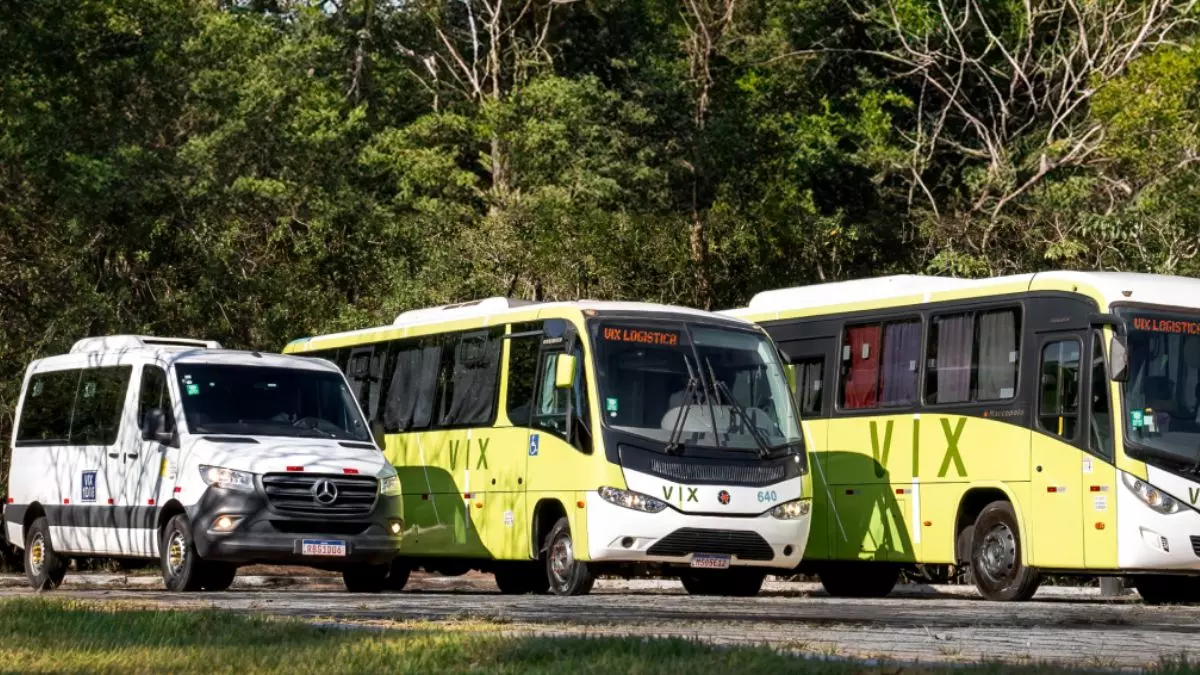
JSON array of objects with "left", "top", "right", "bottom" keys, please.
[{"left": 725, "top": 271, "right": 1200, "bottom": 599}]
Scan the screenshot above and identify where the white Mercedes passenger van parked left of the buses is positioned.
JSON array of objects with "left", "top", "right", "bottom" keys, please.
[{"left": 4, "top": 335, "right": 403, "bottom": 591}]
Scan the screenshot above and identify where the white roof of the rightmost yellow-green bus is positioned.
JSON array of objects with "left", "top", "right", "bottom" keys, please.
[{"left": 720, "top": 271, "right": 1200, "bottom": 319}]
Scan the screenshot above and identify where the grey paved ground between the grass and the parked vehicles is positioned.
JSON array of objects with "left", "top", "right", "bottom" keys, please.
[{"left": 0, "top": 575, "right": 1200, "bottom": 668}]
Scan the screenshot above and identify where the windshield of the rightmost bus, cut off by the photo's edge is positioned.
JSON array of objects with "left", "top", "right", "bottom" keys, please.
[{"left": 1120, "top": 309, "right": 1200, "bottom": 466}]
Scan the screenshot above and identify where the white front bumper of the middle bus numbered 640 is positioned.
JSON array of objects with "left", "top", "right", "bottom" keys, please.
[{"left": 587, "top": 492, "right": 812, "bottom": 569}]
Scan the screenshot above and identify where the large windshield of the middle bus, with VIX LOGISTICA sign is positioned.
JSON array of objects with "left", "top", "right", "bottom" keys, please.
[{"left": 594, "top": 322, "right": 803, "bottom": 453}]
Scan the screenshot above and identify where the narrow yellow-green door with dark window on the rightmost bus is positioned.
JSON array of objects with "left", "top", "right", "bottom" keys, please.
[{"left": 1025, "top": 333, "right": 1087, "bottom": 569}]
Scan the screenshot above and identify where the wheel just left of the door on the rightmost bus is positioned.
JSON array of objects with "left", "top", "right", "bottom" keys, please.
[{"left": 971, "top": 502, "right": 1042, "bottom": 602}]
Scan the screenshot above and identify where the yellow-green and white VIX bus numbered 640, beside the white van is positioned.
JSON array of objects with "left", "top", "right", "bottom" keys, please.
[{"left": 284, "top": 298, "right": 811, "bottom": 581}]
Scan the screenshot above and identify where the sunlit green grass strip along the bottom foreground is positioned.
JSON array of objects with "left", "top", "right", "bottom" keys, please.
[{"left": 0, "top": 598, "right": 1190, "bottom": 675}]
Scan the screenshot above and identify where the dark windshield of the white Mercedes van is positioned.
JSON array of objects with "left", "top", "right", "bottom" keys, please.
[{"left": 175, "top": 364, "right": 371, "bottom": 441}]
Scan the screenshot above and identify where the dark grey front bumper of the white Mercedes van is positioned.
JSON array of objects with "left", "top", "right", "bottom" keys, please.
[{"left": 187, "top": 488, "right": 403, "bottom": 568}]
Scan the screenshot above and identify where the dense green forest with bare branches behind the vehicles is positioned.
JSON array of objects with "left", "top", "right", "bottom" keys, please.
[{"left": 0, "top": 0, "right": 1200, "bottom": 435}]
